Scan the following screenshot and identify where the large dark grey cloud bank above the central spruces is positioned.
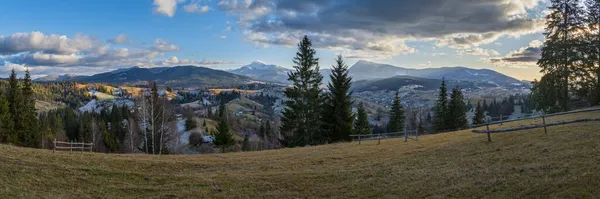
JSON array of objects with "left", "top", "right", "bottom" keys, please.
[{"left": 219, "top": 0, "right": 544, "bottom": 58}]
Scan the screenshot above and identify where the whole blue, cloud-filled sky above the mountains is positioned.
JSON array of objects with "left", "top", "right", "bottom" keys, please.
[{"left": 0, "top": 0, "right": 549, "bottom": 80}]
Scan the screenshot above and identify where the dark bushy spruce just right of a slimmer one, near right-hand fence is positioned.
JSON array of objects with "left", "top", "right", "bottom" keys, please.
[{"left": 445, "top": 87, "right": 469, "bottom": 130}]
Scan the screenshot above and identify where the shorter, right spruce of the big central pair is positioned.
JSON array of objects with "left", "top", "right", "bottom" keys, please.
[{"left": 322, "top": 55, "right": 354, "bottom": 142}]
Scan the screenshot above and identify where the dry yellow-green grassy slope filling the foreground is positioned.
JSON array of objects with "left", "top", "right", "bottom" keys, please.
[{"left": 0, "top": 112, "right": 600, "bottom": 198}]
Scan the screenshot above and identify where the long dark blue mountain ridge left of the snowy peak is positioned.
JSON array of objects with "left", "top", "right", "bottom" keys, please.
[{"left": 36, "top": 66, "right": 254, "bottom": 86}]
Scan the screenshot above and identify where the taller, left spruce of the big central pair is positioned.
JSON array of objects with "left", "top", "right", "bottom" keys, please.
[{"left": 280, "top": 36, "right": 325, "bottom": 147}]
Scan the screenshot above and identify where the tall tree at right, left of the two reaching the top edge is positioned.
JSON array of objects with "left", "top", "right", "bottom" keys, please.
[{"left": 537, "top": 0, "right": 584, "bottom": 111}]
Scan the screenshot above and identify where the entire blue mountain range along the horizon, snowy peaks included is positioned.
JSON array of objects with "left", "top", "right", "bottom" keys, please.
[{"left": 36, "top": 61, "right": 529, "bottom": 90}]
